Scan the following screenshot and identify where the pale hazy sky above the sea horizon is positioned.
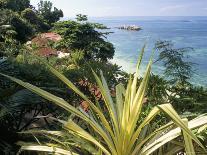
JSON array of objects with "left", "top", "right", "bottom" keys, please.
[{"left": 31, "top": 0, "right": 207, "bottom": 17}]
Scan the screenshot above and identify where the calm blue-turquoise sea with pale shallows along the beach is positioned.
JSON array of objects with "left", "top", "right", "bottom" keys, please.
[{"left": 90, "top": 17, "right": 207, "bottom": 86}]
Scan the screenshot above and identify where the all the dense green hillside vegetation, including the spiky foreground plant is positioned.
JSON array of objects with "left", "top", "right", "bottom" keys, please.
[{"left": 0, "top": 0, "right": 207, "bottom": 155}]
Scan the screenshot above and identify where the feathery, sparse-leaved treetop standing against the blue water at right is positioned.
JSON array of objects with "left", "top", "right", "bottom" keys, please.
[{"left": 156, "top": 41, "right": 193, "bottom": 85}]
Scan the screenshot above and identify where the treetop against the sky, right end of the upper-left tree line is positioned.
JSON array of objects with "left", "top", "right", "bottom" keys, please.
[{"left": 38, "top": 0, "right": 63, "bottom": 25}]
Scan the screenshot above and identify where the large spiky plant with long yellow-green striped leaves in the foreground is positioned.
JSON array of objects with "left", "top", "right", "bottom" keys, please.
[{"left": 1, "top": 48, "right": 207, "bottom": 155}]
